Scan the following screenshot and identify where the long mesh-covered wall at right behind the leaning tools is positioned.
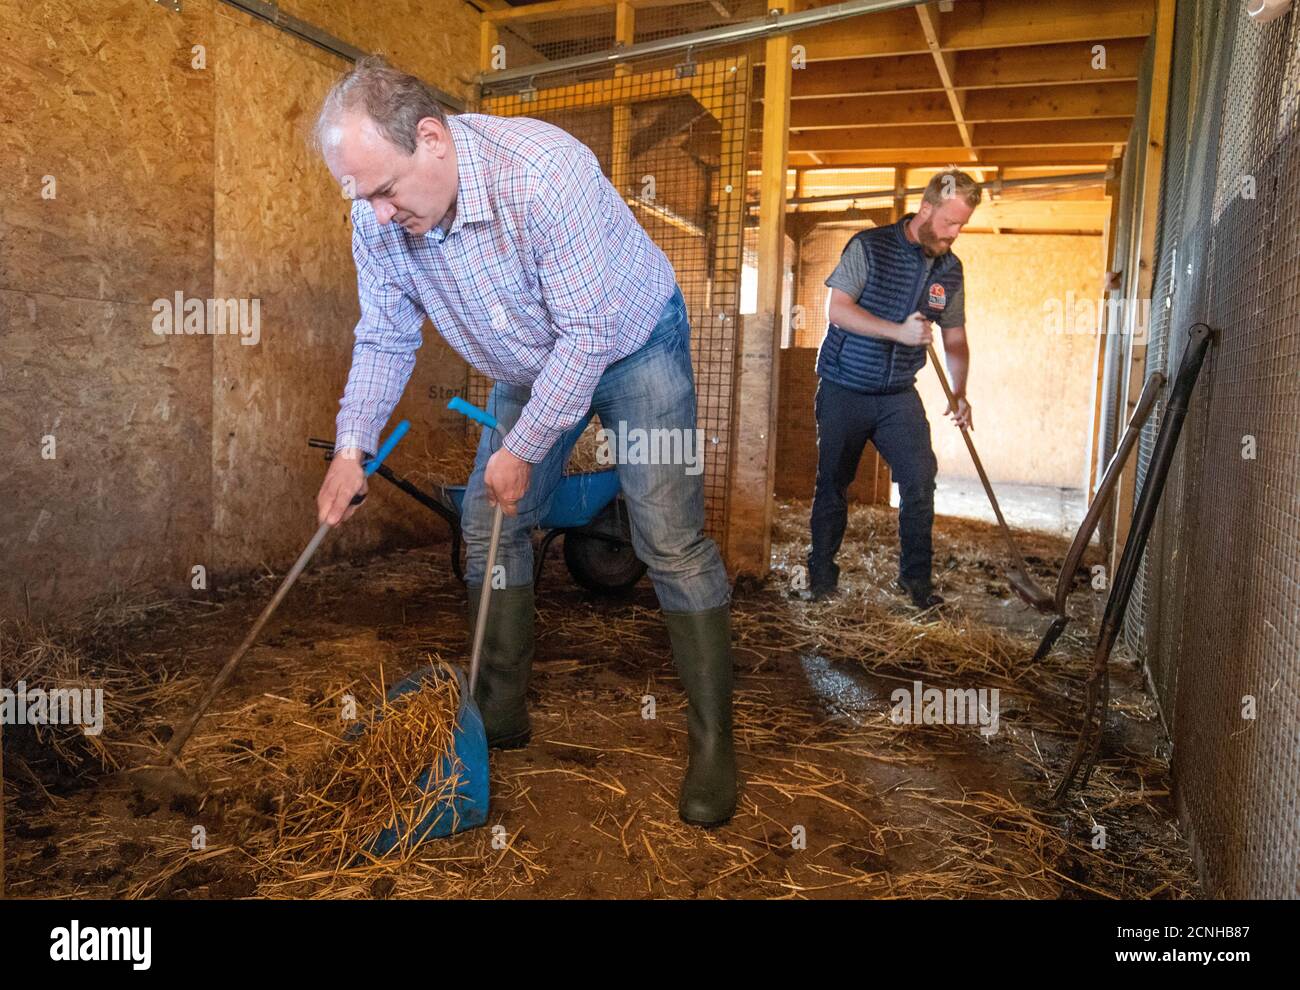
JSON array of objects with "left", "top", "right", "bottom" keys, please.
[{"left": 1107, "top": 0, "right": 1300, "bottom": 898}]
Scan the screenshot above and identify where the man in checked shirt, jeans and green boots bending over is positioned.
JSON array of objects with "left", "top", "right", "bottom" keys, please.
[{"left": 305, "top": 58, "right": 736, "bottom": 828}]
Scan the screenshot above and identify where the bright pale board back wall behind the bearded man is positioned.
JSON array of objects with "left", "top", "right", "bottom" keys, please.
[{"left": 796, "top": 227, "right": 1102, "bottom": 489}]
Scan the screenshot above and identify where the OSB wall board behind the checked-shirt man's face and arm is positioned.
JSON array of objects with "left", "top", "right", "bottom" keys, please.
[{"left": 210, "top": 5, "right": 465, "bottom": 573}]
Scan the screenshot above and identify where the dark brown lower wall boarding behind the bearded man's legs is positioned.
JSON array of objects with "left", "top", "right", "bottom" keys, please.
[{"left": 775, "top": 347, "right": 889, "bottom": 505}]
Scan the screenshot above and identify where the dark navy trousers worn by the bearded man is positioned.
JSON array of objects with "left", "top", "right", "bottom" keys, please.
[{"left": 809, "top": 378, "right": 939, "bottom": 589}]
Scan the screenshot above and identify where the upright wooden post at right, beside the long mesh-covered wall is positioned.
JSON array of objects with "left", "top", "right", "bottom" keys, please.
[{"left": 1110, "top": 0, "right": 1175, "bottom": 563}]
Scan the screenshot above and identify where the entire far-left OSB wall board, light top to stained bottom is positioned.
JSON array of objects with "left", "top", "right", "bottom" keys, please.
[{"left": 0, "top": 0, "right": 213, "bottom": 615}]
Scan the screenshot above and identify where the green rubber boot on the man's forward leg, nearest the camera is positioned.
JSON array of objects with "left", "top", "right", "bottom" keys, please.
[{"left": 663, "top": 605, "right": 736, "bottom": 829}]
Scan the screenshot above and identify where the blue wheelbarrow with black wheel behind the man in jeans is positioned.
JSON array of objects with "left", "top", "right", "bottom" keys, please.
[{"left": 307, "top": 418, "right": 646, "bottom": 596}]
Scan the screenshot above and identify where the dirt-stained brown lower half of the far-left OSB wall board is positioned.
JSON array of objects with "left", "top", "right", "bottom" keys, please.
[{"left": 0, "top": 290, "right": 212, "bottom": 615}]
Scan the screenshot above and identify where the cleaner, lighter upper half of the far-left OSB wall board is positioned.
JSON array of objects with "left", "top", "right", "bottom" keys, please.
[{"left": 0, "top": 0, "right": 212, "bottom": 303}]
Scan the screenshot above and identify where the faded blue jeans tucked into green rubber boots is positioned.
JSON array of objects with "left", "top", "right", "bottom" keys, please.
[{"left": 460, "top": 281, "right": 731, "bottom": 612}]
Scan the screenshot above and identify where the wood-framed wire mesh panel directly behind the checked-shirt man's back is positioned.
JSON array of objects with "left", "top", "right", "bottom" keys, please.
[{"left": 471, "top": 50, "right": 750, "bottom": 540}]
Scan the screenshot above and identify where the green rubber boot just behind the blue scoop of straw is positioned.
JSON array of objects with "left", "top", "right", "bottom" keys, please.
[{"left": 467, "top": 585, "right": 533, "bottom": 750}]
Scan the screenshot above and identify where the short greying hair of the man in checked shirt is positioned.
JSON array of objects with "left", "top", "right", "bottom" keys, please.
[{"left": 312, "top": 55, "right": 447, "bottom": 155}]
